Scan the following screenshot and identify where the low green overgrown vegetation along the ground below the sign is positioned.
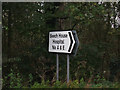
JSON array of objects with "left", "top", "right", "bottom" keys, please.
[{"left": 3, "top": 70, "right": 120, "bottom": 88}]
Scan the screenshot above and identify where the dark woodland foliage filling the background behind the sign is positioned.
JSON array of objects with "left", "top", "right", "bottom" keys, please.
[{"left": 2, "top": 2, "right": 120, "bottom": 87}]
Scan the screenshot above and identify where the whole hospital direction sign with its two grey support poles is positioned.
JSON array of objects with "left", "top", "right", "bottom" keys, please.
[{"left": 48, "top": 31, "right": 79, "bottom": 83}]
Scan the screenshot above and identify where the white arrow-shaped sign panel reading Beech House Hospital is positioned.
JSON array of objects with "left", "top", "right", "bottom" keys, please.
[{"left": 49, "top": 31, "right": 75, "bottom": 53}]
